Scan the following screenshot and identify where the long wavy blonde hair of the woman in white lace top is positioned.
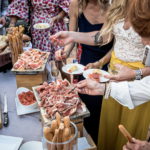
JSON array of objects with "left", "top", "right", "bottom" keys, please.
[{"left": 100, "top": 0, "right": 129, "bottom": 43}]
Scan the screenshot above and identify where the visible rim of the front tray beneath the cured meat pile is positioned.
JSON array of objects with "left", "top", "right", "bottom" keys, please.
[{"left": 32, "top": 86, "right": 90, "bottom": 124}]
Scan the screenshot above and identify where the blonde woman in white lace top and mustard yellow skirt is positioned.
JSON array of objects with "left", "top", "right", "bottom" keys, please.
[{"left": 51, "top": 0, "right": 150, "bottom": 150}]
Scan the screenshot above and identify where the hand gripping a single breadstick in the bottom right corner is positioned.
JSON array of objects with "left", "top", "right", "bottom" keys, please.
[{"left": 123, "top": 138, "right": 150, "bottom": 150}]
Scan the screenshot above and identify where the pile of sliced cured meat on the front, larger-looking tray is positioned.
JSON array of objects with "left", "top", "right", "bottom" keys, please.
[{"left": 36, "top": 80, "right": 85, "bottom": 118}]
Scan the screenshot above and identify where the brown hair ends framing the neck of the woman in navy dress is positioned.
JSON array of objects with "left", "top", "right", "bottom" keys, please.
[{"left": 78, "top": 0, "right": 109, "bottom": 15}]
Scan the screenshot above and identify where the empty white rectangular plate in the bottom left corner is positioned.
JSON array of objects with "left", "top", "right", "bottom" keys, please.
[{"left": 0, "top": 135, "right": 23, "bottom": 150}]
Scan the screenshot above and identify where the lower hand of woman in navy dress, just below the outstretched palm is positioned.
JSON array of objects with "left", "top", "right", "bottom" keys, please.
[{"left": 55, "top": 49, "right": 69, "bottom": 61}]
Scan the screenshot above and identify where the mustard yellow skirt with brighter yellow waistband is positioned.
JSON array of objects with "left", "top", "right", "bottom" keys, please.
[{"left": 98, "top": 51, "right": 150, "bottom": 150}]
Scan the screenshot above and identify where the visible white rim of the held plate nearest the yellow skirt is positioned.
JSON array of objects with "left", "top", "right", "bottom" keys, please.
[{"left": 83, "top": 69, "right": 109, "bottom": 82}]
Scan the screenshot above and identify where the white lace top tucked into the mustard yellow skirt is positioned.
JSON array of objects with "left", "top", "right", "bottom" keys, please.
[{"left": 113, "top": 19, "right": 145, "bottom": 62}]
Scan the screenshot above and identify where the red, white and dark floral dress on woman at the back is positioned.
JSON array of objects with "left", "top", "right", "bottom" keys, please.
[{"left": 7, "top": 0, "right": 70, "bottom": 59}]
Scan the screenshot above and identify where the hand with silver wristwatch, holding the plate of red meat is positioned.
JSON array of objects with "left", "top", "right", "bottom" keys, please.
[{"left": 105, "top": 64, "right": 135, "bottom": 81}]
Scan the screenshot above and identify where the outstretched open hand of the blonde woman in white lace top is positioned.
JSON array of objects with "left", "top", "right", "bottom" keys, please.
[{"left": 50, "top": 31, "right": 74, "bottom": 46}]
